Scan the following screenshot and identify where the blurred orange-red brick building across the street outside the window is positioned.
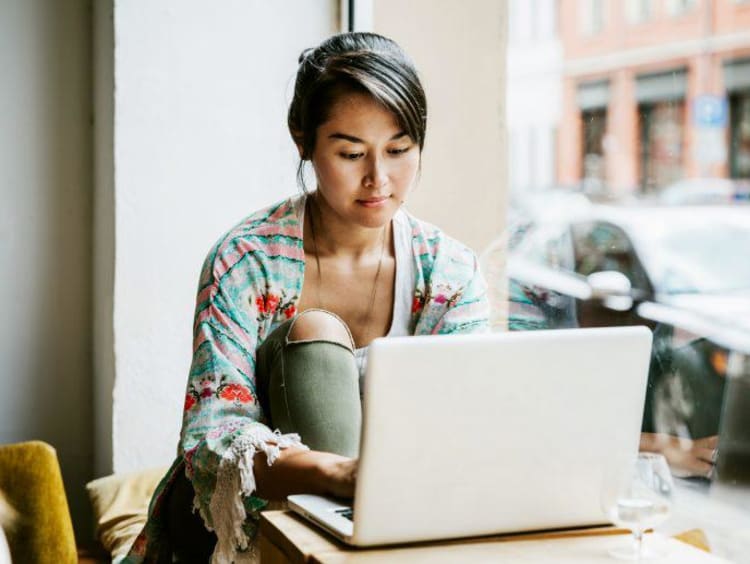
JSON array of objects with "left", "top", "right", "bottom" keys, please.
[{"left": 557, "top": 0, "right": 750, "bottom": 194}]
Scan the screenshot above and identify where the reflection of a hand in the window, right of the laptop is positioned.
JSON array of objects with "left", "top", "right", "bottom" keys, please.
[{"left": 640, "top": 433, "right": 719, "bottom": 478}]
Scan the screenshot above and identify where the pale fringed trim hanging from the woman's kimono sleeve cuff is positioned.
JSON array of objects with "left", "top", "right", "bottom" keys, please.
[{"left": 210, "top": 426, "right": 307, "bottom": 564}]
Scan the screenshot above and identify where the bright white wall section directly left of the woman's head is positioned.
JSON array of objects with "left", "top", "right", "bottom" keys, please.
[{"left": 96, "top": 0, "right": 338, "bottom": 471}]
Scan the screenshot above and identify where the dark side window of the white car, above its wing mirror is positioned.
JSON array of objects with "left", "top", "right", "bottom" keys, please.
[{"left": 572, "top": 221, "right": 649, "bottom": 290}]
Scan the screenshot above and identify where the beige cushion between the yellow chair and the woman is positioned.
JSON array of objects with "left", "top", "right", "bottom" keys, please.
[{"left": 86, "top": 466, "right": 169, "bottom": 558}]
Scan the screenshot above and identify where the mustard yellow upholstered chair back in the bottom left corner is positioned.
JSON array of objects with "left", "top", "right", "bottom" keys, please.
[{"left": 0, "top": 441, "right": 78, "bottom": 564}]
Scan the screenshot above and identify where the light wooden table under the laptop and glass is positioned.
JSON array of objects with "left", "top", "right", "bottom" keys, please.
[{"left": 259, "top": 511, "right": 727, "bottom": 564}]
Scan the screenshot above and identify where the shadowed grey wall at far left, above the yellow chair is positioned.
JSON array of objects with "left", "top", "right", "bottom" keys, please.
[{"left": 0, "top": 0, "right": 93, "bottom": 538}]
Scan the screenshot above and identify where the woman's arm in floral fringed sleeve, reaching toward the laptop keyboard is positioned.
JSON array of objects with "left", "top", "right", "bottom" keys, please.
[{"left": 180, "top": 248, "right": 335, "bottom": 561}]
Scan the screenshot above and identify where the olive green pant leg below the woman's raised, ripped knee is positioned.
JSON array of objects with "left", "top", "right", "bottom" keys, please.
[{"left": 257, "top": 320, "right": 362, "bottom": 457}]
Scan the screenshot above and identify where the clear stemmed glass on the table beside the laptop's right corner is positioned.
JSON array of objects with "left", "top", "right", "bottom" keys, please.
[{"left": 602, "top": 452, "right": 674, "bottom": 561}]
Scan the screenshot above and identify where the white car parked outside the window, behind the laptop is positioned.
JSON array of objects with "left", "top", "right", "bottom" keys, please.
[{"left": 490, "top": 194, "right": 750, "bottom": 446}]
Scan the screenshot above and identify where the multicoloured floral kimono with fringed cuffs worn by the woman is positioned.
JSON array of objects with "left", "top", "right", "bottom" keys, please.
[{"left": 124, "top": 196, "right": 489, "bottom": 563}]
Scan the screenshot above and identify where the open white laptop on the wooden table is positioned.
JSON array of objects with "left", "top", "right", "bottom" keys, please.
[{"left": 288, "top": 327, "right": 651, "bottom": 546}]
